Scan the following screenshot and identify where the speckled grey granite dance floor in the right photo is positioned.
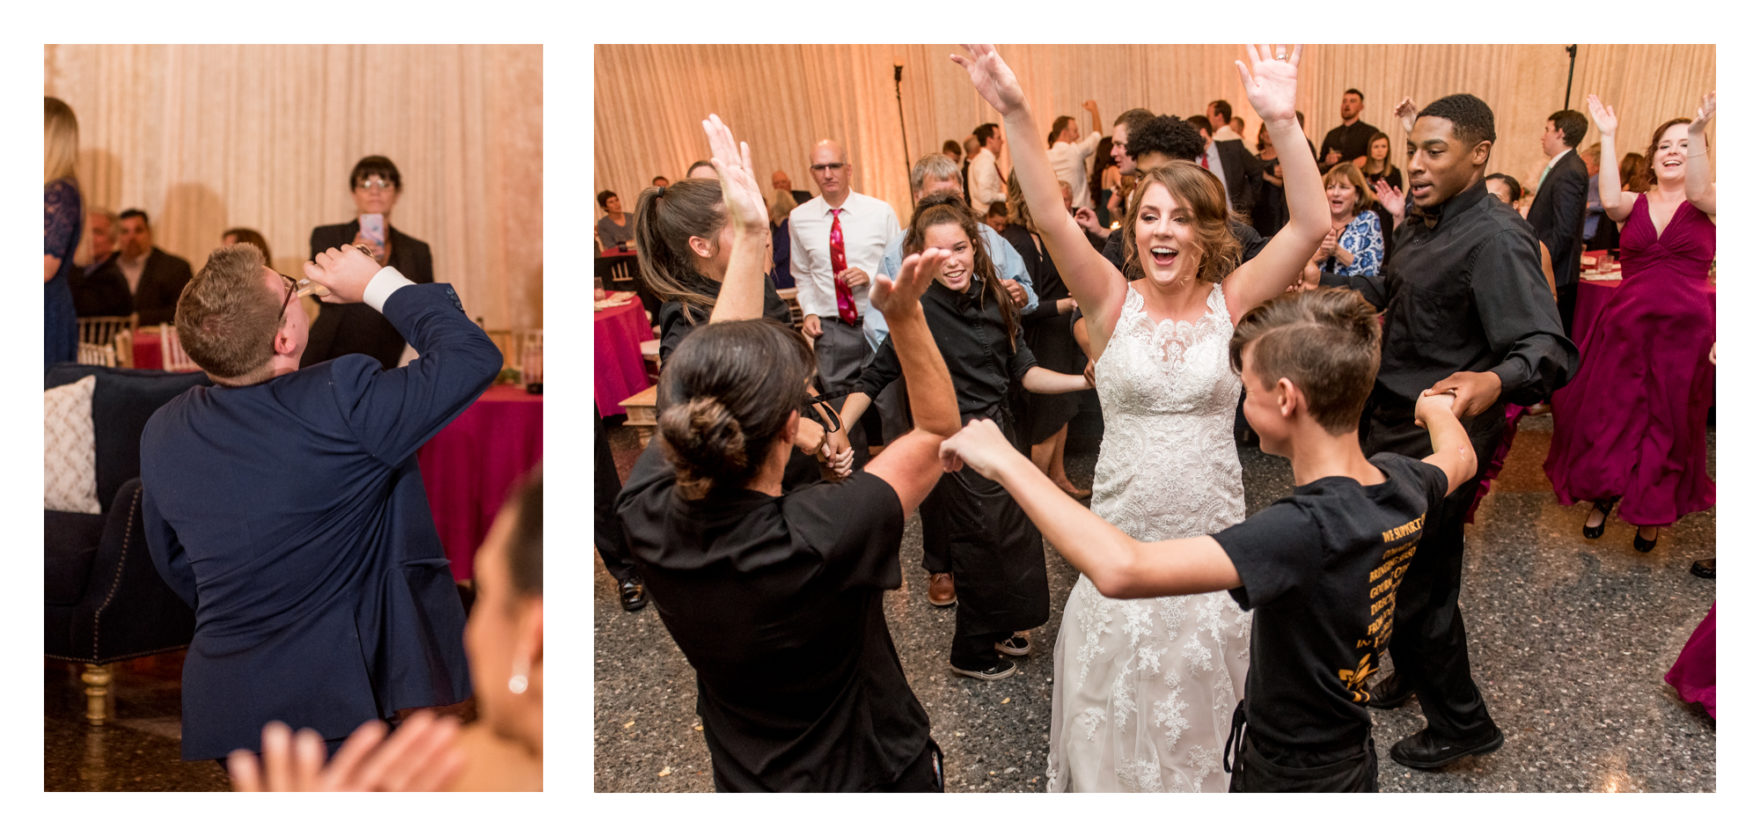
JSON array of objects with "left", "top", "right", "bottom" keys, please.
[{"left": 593, "top": 415, "right": 1716, "bottom": 792}]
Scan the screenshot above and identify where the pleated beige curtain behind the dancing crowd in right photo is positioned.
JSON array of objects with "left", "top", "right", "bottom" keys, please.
[{"left": 593, "top": 44, "right": 1718, "bottom": 218}]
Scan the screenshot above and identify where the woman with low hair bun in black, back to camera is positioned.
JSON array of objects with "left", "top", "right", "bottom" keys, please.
[{"left": 618, "top": 163, "right": 959, "bottom": 792}]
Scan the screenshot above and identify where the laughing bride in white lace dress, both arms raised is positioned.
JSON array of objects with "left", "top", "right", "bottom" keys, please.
[{"left": 954, "top": 44, "right": 1331, "bottom": 792}]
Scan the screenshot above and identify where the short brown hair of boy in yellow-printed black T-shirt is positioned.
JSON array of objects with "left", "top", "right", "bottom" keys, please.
[{"left": 1228, "top": 287, "right": 1382, "bottom": 435}]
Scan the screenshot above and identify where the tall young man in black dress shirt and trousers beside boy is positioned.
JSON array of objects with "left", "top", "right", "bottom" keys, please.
[{"left": 1322, "top": 93, "right": 1577, "bottom": 769}]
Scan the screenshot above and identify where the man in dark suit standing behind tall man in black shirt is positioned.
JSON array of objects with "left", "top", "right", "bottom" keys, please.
[{"left": 1528, "top": 111, "right": 1589, "bottom": 334}]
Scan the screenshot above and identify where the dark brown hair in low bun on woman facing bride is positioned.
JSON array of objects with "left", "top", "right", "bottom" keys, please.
[{"left": 656, "top": 319, "right": 815, "bottom": 500}]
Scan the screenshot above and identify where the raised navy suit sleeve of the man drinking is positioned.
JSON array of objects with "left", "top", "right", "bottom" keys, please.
[{"left": 331, "top": 285, "right": 502, "bottom": 465}]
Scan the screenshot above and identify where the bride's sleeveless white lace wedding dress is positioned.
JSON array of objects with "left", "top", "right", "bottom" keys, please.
[{"left": 1045, "top": 285, "right": 1253, "bottom": 792}]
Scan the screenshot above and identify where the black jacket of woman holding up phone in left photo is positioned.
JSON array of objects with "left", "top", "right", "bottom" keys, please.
[{"left": 299, "top": 218, "right": 435, "bottom": 368}]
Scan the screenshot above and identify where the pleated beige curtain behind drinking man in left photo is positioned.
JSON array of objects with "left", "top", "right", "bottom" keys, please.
[{"left": 42, "top": 44, "right": 544, "bottom": 329}]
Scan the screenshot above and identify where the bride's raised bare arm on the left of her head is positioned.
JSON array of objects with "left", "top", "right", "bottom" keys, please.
[{"left": 952, "top": 44, "right": 1125, "bottom": 357}]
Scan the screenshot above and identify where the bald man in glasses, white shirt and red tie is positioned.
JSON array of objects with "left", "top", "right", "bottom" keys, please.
[{"left": 788, "top": 139, "right": 899, "bottom": 465}]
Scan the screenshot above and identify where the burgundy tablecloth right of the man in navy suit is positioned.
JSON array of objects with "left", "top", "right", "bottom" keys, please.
[{"left": 415, "top": 384, "right": 544, "bottom": 581}]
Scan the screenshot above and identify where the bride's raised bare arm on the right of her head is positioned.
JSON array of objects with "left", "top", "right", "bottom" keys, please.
[{"left": 1221, "top": 44, "right": 1332, "bottom": 322}]
